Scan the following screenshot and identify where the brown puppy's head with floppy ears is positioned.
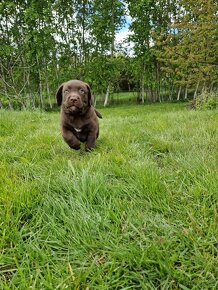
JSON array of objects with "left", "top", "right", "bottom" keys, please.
[{"left": 56, "top": 80, "right": 92, "bottom": 115}]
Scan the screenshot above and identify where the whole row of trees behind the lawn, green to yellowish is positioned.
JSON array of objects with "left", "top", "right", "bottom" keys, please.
[{"left": 0, "top": 0, "right": 218, "bottom": 108}]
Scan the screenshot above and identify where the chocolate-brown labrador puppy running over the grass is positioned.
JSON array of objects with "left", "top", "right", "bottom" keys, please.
[{"left": 56, "top": 80, "right": 102, "bottom": 151}]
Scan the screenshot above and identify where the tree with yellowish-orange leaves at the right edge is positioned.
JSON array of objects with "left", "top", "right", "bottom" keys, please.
[{"left": 153, "top": 0, "right": 218, "bottom": 99}]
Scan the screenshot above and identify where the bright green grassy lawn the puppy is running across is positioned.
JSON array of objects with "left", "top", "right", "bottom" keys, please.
[{"left": 0, "top": 104, "right": 218, "bottom": 290}]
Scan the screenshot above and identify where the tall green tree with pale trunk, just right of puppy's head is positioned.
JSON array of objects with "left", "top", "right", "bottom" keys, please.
[{"left": 90, "top": 0, "right": 124, "bottom": 106}]
